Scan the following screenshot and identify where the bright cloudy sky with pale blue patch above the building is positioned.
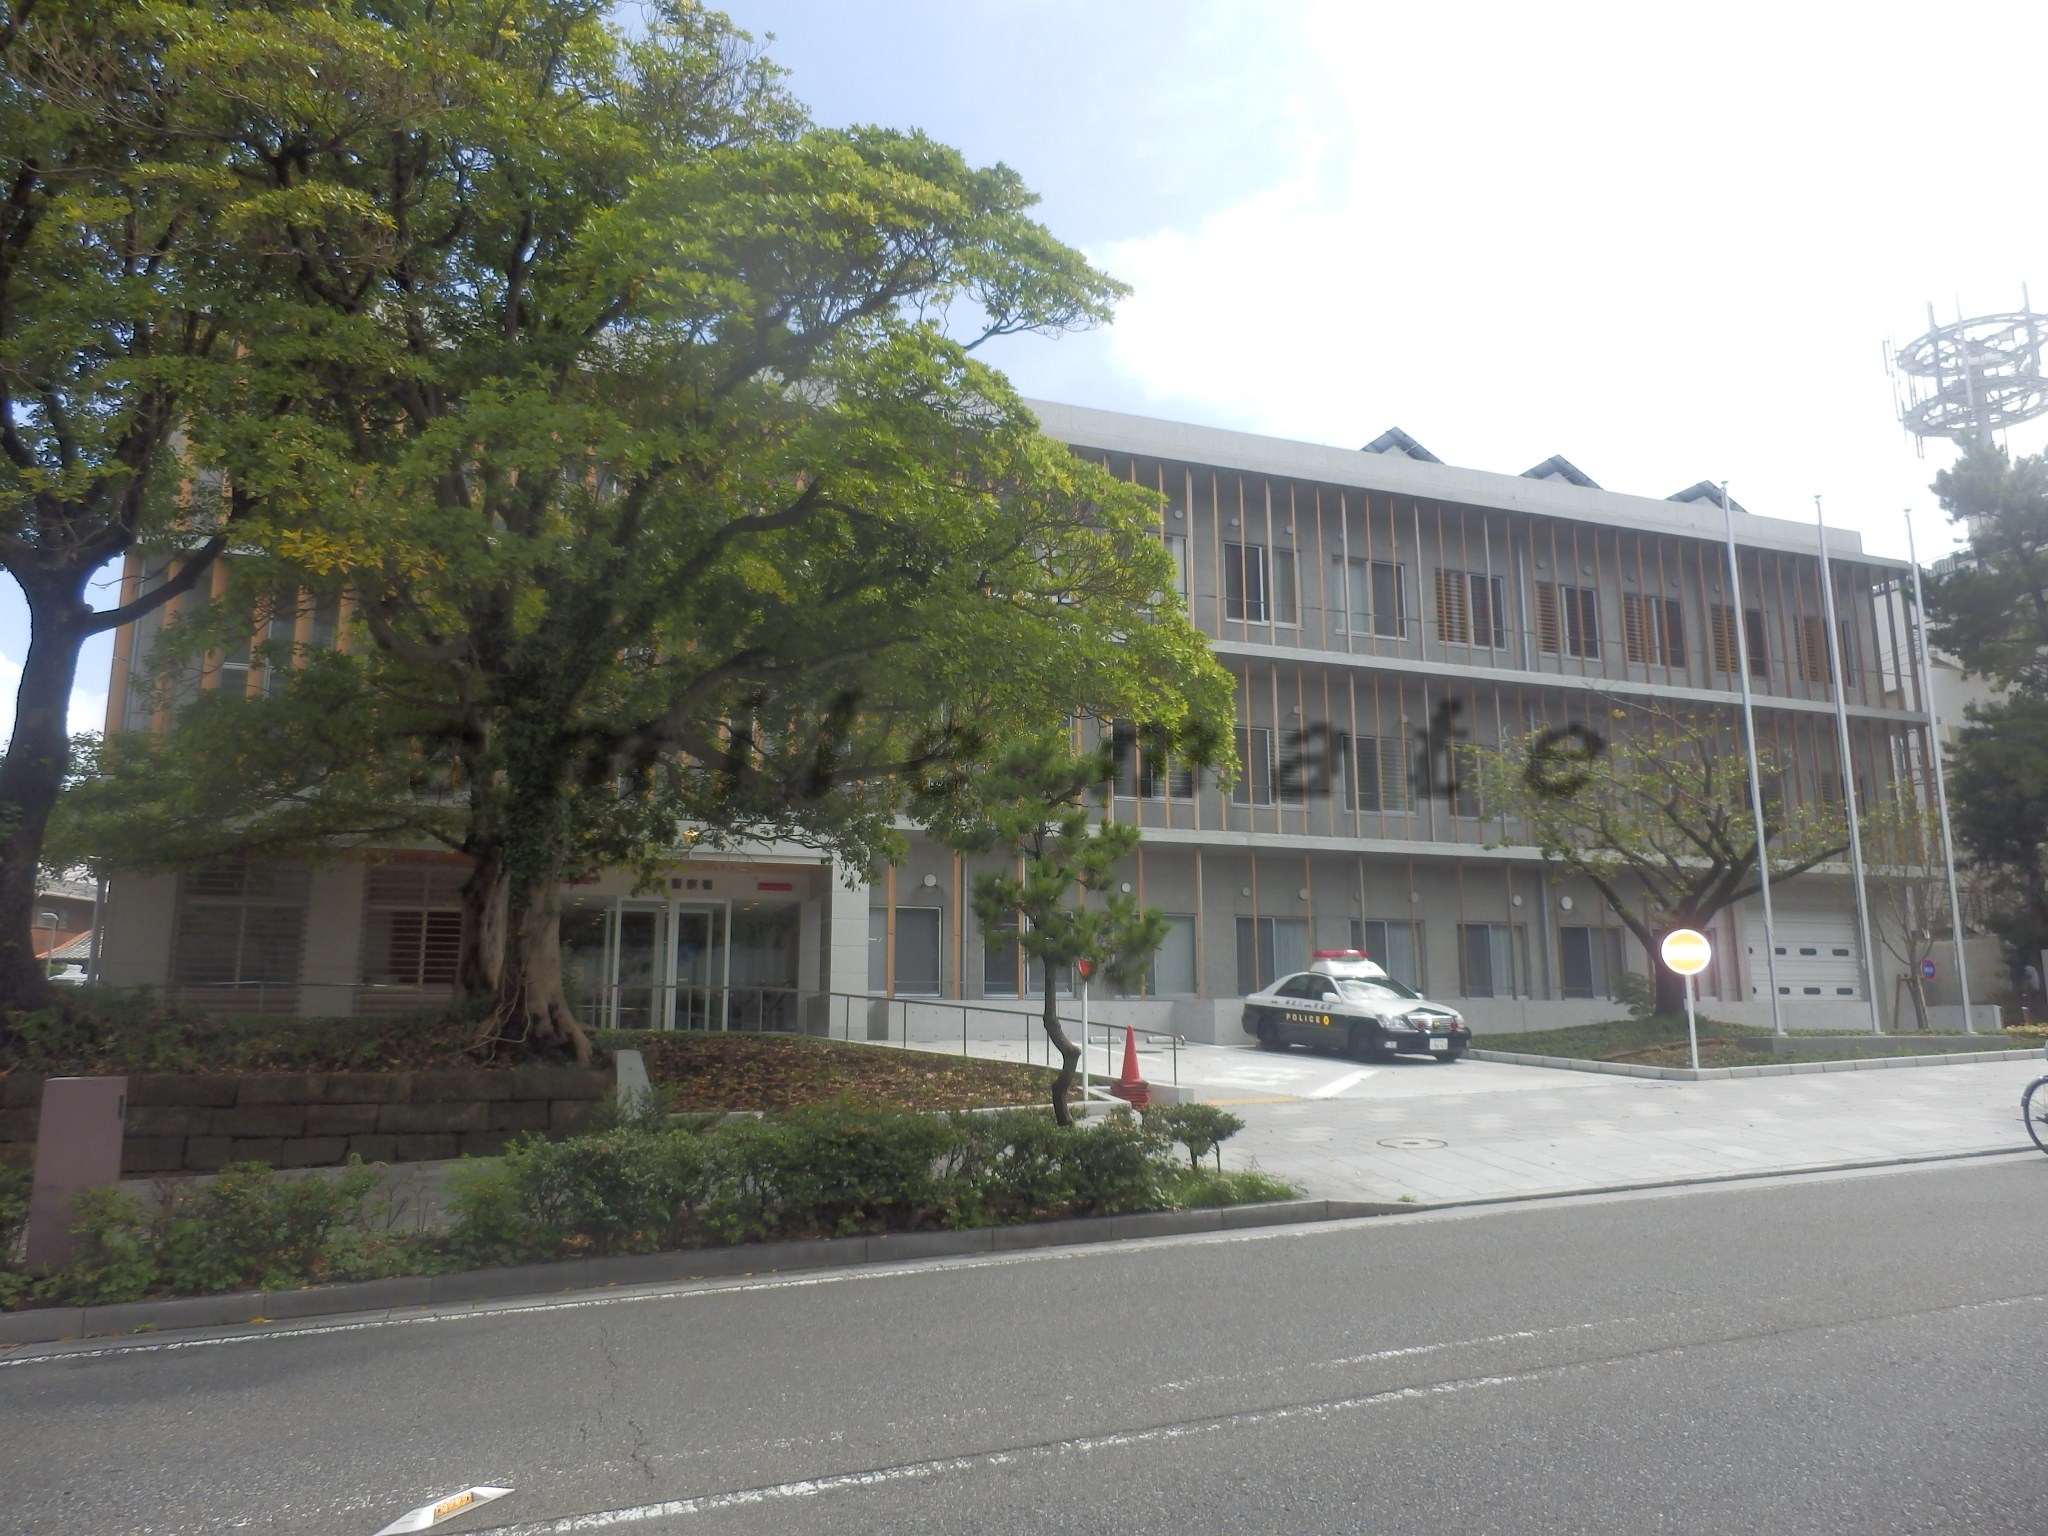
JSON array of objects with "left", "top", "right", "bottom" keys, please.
[{"left": 16, "top": 0, "right": 2048, "bottom": 745}]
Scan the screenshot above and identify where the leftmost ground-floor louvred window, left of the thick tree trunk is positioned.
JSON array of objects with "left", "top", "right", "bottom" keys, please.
[{"left": 170, "top": 860, "right": 311, "bottom": 1012}]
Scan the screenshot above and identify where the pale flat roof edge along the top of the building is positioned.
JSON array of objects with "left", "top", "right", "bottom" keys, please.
[{"left": 1024, "top": 399, "right": 1911, "bottom": 571}]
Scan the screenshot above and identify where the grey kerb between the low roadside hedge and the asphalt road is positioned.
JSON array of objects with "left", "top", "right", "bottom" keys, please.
[{"left": 0, "top": 1200, "right": 1419, "bottom": 1346}]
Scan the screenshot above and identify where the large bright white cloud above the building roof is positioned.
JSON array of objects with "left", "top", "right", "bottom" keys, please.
[{"left": 1061, "top": 4, "right": 2048, "bottom": 553}]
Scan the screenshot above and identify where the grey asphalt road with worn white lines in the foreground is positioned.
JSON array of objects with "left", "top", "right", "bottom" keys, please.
[{"left": 0, "top": 1155, "right": 2048, "bottom": 1536}]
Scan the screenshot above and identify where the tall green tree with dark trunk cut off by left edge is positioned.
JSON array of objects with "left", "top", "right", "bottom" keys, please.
[{"left": 0, "top": 0, "right": 323, "bottom": 1010}]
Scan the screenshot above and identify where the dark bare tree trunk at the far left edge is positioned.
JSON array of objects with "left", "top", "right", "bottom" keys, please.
[{"left": 0, "top": 604, "right": 84, "bottom": 1024}]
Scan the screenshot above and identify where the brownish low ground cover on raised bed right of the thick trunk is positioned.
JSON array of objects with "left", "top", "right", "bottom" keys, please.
[{"left": 594, "top": 1030, "right": 1055, "bottom": 1114}]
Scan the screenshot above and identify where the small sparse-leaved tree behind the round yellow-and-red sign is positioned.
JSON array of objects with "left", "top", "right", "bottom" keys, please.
[{"left": 1464, "top": 702, "right": 1849, "bottom": 1014}]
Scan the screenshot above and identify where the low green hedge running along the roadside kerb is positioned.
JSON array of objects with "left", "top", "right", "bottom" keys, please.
[{"left": 0, "top": 1106, "right": 1298, "bottom": 1307}]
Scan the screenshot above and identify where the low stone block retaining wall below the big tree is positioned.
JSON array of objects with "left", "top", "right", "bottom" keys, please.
[{"left": 0, "top": 1067, "right": 612, "bottom": 1176}]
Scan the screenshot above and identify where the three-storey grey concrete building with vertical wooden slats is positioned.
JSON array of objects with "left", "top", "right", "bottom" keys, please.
[{"left": 88, "top": 403, "right": 1927, "bottom": 1040}]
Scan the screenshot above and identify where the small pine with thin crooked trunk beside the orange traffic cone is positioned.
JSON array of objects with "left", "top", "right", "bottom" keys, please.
[{"left": 932, "top": 735, "right": 1167, "bottom": 1124}]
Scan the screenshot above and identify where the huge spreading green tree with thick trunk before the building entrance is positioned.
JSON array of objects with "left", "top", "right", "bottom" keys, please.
[{"left": 64, "top": 0, "right": 1229, "bottom": 1053}]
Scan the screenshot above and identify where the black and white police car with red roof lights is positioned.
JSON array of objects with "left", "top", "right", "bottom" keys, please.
[{"left": 1243, "top": 950, "right": 1473, "bottom": 1061}]
